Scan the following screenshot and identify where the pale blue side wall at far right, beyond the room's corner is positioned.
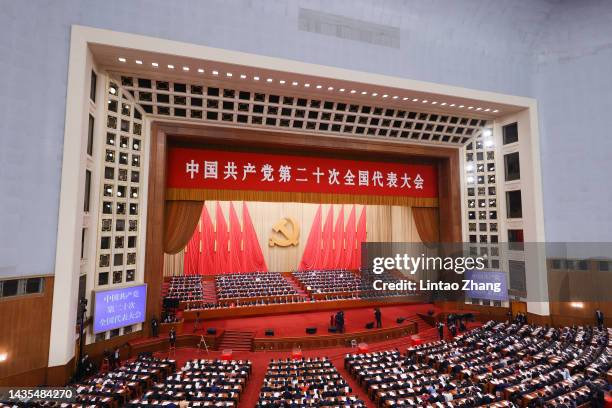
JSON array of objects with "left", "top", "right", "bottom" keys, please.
[{"left": 534, "top": 0, "right": 612, "bottom": 242}]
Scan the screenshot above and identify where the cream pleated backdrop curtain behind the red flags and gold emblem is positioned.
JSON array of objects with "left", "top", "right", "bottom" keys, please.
[{"left": 164, "top": 201, "right": 421, "bottom": 276}]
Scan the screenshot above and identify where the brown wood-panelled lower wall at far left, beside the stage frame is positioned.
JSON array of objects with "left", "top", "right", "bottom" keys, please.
[{"left": 0, "top": 277, "right": 53, "bottom": 385}]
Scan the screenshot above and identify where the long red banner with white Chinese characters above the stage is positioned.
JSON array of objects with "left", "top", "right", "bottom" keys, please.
[{"left": 167, "top": 148, "right": 438, "bottom": 198}]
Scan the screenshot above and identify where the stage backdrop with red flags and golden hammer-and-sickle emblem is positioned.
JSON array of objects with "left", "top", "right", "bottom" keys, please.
[{"left": 164, "top": 201, "right": 421, "bottom": 276}]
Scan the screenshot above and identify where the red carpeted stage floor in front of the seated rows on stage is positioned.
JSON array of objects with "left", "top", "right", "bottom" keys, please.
[{"left": 191, "top": 304, "right": 435, "bottom": 337}]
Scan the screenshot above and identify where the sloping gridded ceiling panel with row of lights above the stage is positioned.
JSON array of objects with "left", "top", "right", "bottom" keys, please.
[{"left": 90, "top": 44, "right": 522, "bottom": 147}]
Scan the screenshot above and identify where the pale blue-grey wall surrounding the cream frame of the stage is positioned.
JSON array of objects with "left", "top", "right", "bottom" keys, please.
[{"left": 0, "top": 0, "right": 612, "bottom": 277}]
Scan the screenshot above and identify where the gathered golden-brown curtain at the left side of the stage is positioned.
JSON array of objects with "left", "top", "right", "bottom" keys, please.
[{"left": 164, "top": 201, "right": 204, "bottom": 254}]
